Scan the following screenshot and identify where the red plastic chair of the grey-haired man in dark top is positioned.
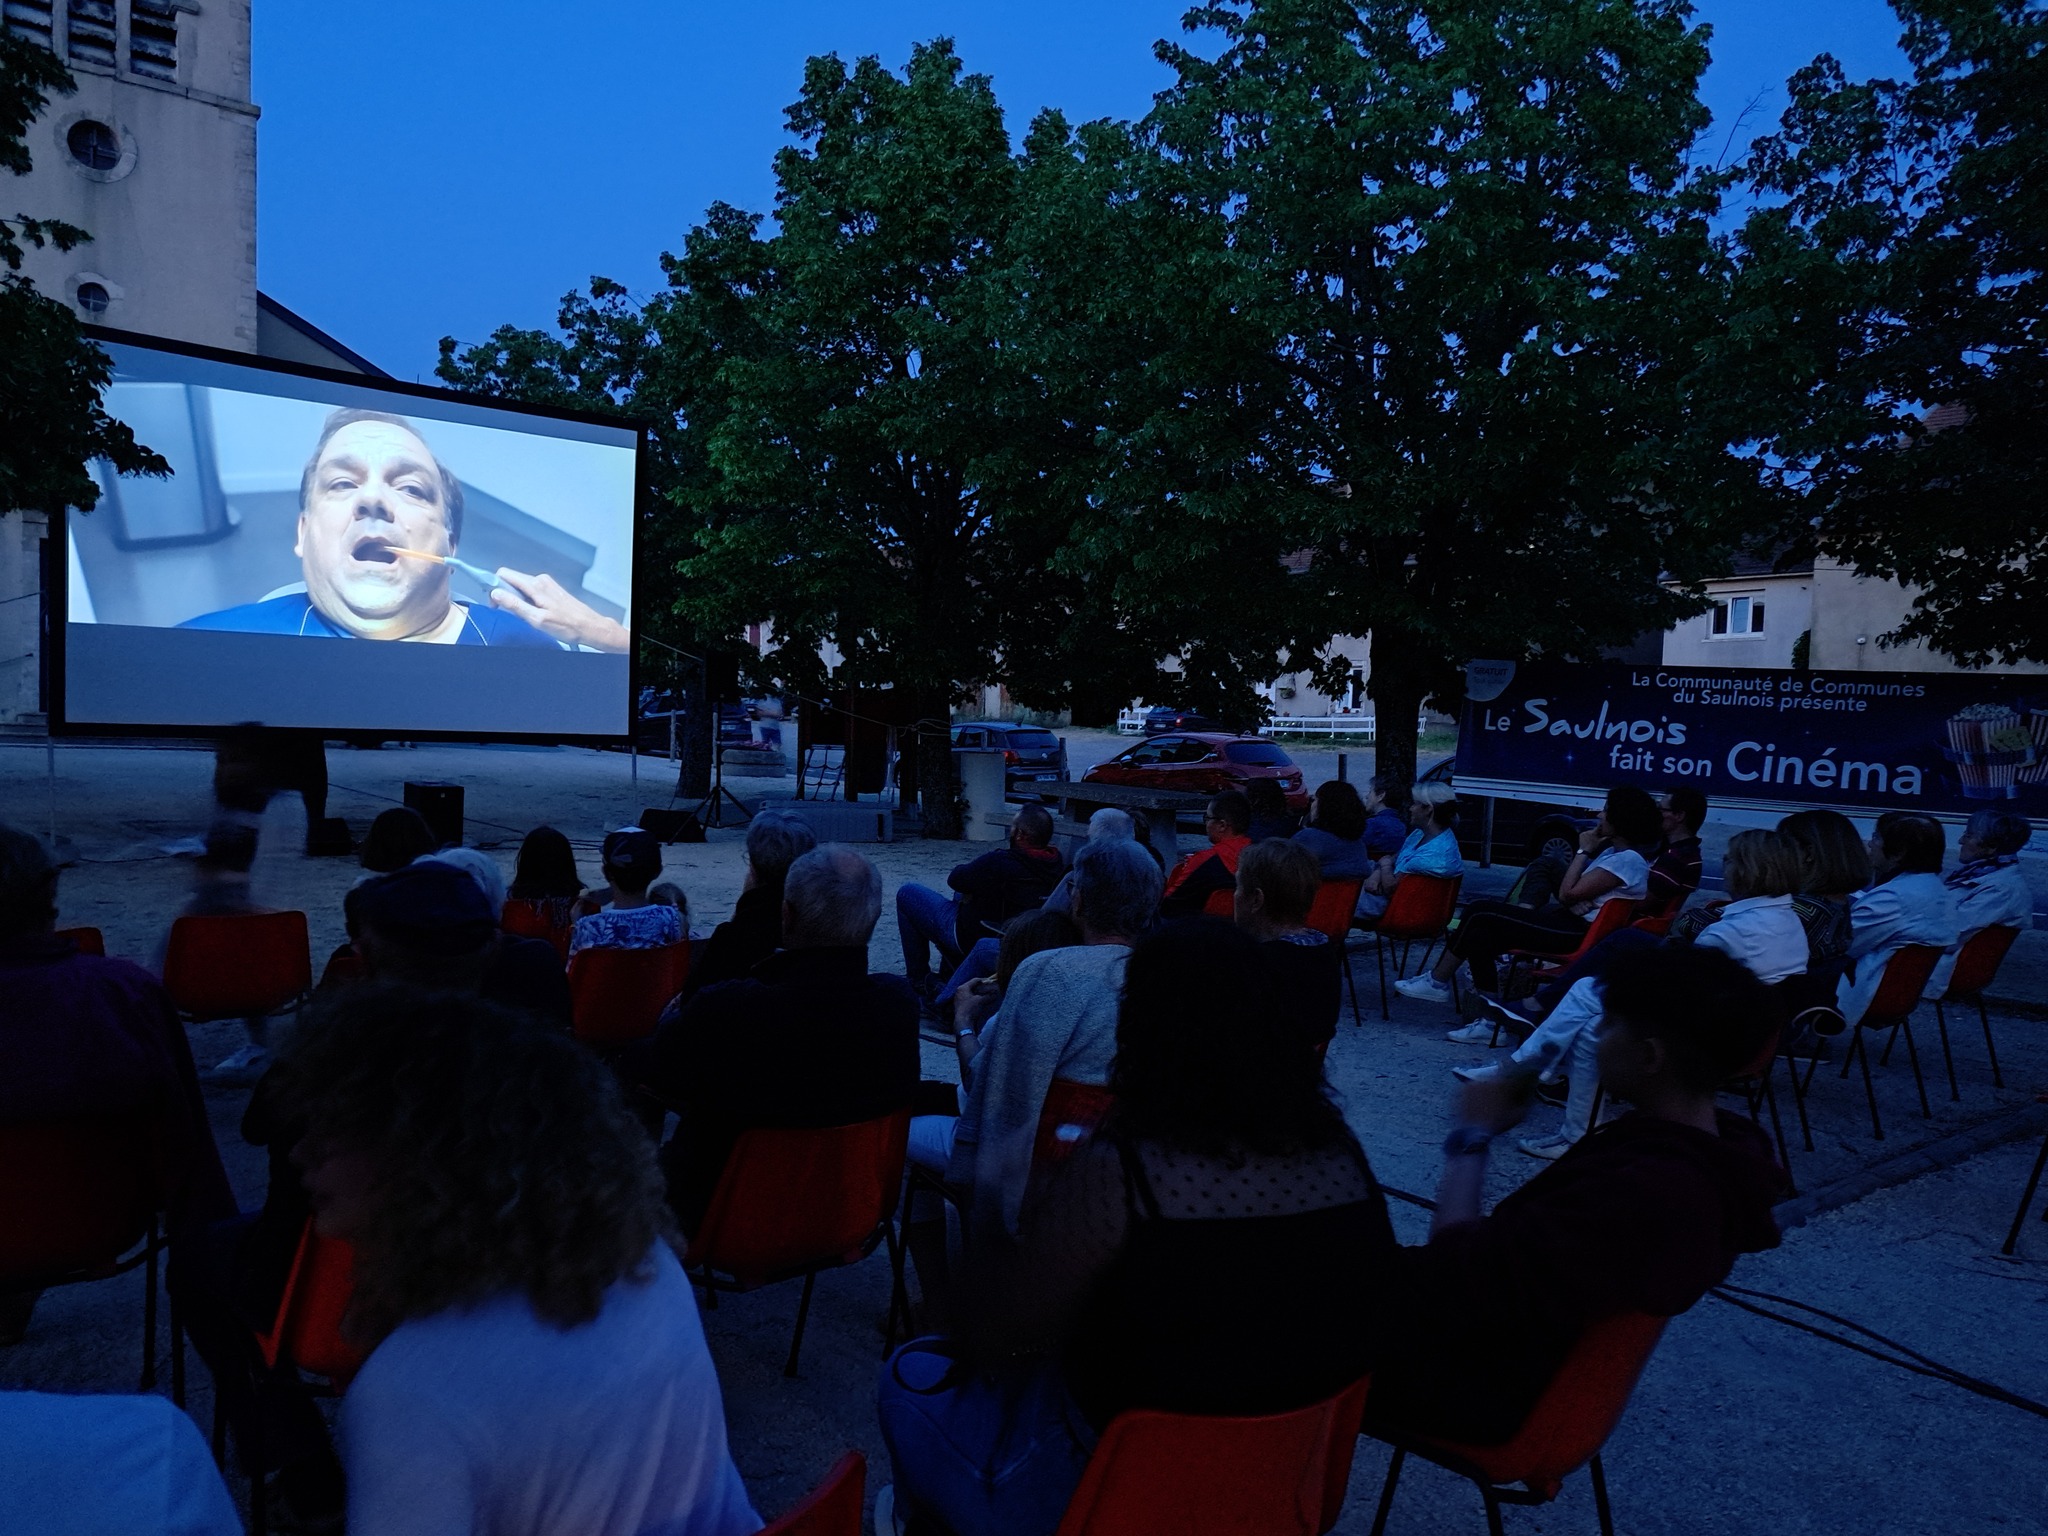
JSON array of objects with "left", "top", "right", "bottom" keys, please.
[{"left": 682, "top": 1110, "right": 909, "bottom": 1376}]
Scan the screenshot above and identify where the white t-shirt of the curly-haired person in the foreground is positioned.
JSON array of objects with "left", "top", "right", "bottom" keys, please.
[{"left": 342, "top": 1243, "right": 762, "bottom": 1536}]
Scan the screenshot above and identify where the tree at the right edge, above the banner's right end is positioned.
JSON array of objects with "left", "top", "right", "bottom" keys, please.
[{"left": 1741, "top": 0, "right": 2048, "bottom": 666}]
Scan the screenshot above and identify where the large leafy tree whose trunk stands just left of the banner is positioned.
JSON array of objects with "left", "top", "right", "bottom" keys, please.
[{"left": 1064, "top": 0, "right": 1772, "bottom": 774}]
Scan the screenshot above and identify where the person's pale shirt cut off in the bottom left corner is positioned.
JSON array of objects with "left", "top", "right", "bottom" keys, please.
[{"left": 0, "top": 1393, "right": 242, "bottom": 1536}]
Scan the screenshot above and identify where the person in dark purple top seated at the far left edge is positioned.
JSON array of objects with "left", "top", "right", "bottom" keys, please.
[{"left": 0, "top": 823, "right": 236, "bottom": 1343}]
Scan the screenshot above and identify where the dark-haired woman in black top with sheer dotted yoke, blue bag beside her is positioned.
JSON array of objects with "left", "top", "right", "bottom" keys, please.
[{"left": 877, "top": 921, "right": 1395, "bottom": 1536}]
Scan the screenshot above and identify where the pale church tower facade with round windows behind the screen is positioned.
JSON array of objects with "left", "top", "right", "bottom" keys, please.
[{"left": 0, "top": 0, "right": 379, "bottom": 731}]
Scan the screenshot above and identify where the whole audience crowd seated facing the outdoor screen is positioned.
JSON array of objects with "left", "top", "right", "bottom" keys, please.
[{"left": 0, "top": 741, "right": 2032, "bottom": 1536}]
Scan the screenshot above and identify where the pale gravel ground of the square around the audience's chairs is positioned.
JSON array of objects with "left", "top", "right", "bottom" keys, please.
[{"left": 0, "top": 733, "right": 2048, "bottom": 1534}]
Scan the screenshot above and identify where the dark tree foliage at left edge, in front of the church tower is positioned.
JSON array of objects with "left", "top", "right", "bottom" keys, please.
[{"left": 0, "top": 31, "right": 170, "bottom": 516}]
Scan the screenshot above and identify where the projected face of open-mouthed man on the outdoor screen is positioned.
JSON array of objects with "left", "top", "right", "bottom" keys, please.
[{"left": 295, "top": 422, "right": 455, "bottom": 639}]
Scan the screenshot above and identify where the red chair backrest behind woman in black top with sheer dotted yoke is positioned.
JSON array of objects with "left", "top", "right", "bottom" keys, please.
[{"left": 1059, "top": 1380, "right": 1368, "bottom": 1536}]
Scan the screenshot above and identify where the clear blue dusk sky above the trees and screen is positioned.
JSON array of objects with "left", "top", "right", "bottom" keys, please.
[{"left": 254, "top": 0, "right": 1903, "bottom": 379}]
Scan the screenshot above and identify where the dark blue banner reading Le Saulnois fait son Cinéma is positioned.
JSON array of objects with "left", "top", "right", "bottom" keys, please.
[{"left": 1456, "top": 662, "right": 2048, "bottom": 831}]
